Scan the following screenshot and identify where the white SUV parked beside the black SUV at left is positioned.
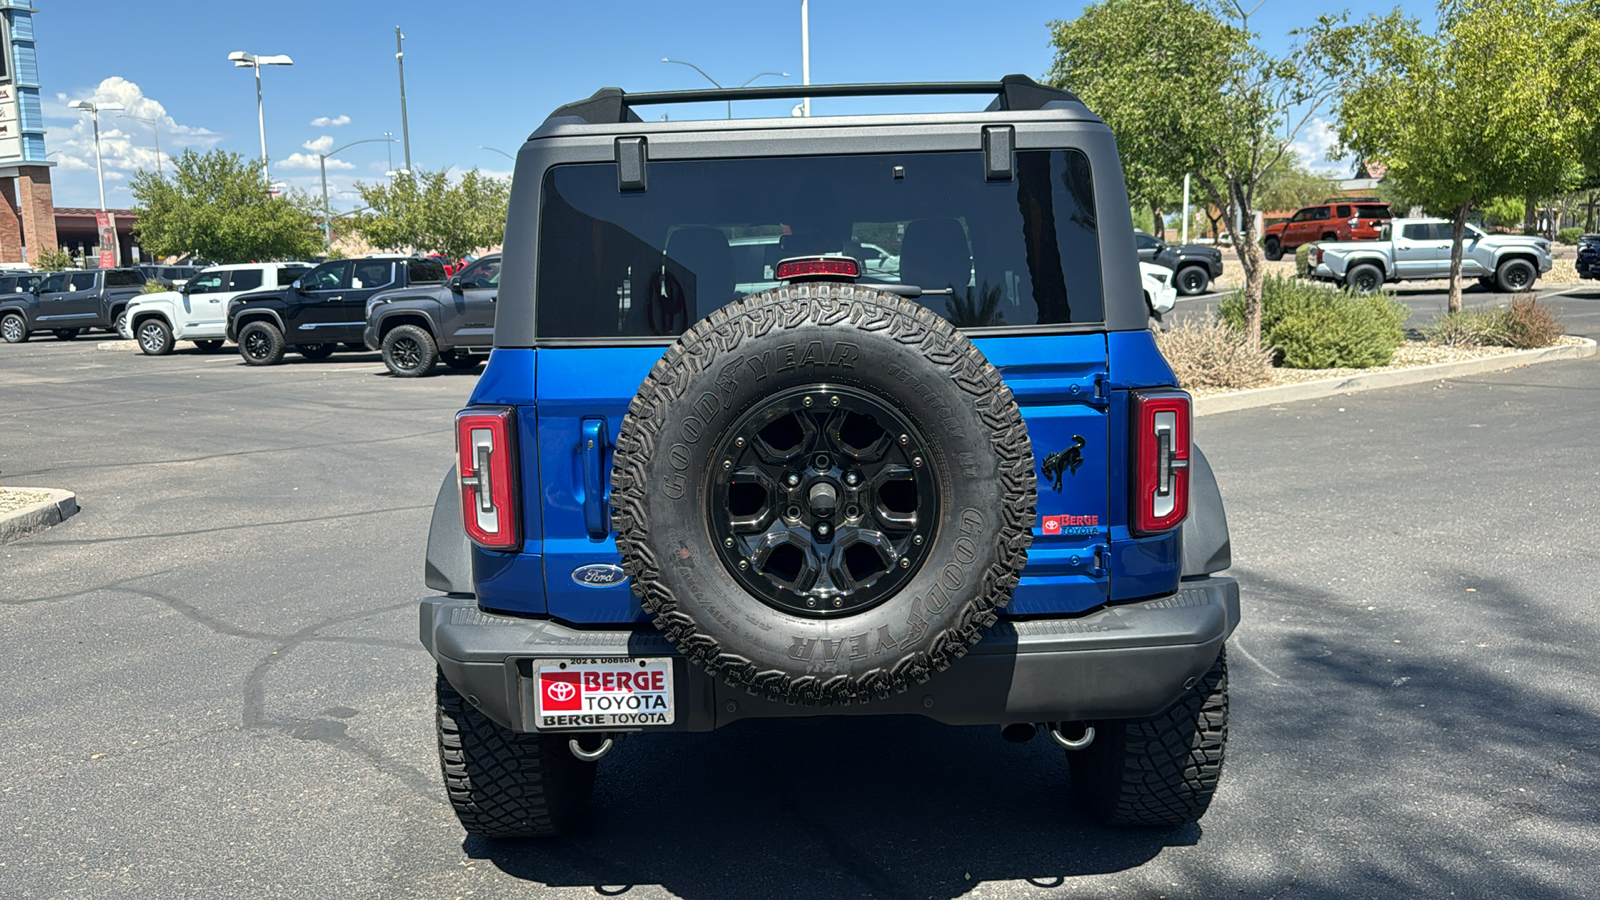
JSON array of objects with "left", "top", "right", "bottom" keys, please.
[{"left": 122, "top": 263, "right": 315, "bottom": 356}]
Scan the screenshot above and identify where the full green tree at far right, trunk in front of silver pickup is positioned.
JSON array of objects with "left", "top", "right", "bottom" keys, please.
[{"left": 1339, "top": 0, "right": 1600, "bottom": 312}]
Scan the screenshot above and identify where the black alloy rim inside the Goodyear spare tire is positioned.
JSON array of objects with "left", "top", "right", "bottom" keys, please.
[{"left": 707, "top": 384, "right": 941, "bottom": 617}]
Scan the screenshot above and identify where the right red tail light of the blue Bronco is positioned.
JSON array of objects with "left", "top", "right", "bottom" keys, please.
[{"left": 1133, "top": 391, "right": 1189, "bottom": 535}]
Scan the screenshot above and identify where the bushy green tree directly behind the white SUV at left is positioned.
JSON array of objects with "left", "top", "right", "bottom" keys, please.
[{"left": 128, "top": 149, "right": 322, "bottom": 263}]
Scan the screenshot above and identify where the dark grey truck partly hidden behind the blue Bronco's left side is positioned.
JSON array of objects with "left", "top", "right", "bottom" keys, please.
[{"left": 362, "top": 253, "right": 501, "bottom": 378}]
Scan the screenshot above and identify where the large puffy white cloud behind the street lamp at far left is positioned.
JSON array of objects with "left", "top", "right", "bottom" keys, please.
[{"left": 42, "top": 77, "right": 222, "bottom": 207}]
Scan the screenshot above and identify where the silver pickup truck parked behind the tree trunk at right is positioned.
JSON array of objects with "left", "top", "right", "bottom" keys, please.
[{"left": 1310, "top": 219, "right": 1550, "bottom": 293}]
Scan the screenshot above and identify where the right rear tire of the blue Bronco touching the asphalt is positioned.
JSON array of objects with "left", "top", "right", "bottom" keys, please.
[{"left": 1067, "top": 650, "right": 1227, "bottom": 826}]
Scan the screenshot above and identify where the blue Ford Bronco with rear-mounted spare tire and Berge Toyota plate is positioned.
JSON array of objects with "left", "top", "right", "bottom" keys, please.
[{"left": 421, "top": 75, "right": 1238, "bottom": 836}]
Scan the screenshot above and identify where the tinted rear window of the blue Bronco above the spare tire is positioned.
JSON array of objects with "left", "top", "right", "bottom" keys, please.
[{"left": 538, "top": 151, "right": 1104, "bottom": 338}]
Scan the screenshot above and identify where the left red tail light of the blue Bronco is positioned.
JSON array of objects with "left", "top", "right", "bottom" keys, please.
[{"left": 456, "top": 407, "right": 522, "bottom": 549}]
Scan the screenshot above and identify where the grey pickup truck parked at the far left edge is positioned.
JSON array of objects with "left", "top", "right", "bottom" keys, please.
[{"left": 0, "top": 269, "right": 144, "bottom": 344}]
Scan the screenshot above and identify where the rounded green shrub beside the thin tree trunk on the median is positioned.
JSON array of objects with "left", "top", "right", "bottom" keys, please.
[{"left": 1221, "top": 277, "right": 1410, "bottom": 368}]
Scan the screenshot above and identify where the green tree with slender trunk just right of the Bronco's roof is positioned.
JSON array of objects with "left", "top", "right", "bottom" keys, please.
[{"left": 1046, "top": 0, "right": 1355, "bottom": 348}]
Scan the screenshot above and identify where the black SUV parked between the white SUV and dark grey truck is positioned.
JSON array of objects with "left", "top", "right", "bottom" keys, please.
[{"left": 227, "top": 256, "right": 445, "bottom": 365}]
